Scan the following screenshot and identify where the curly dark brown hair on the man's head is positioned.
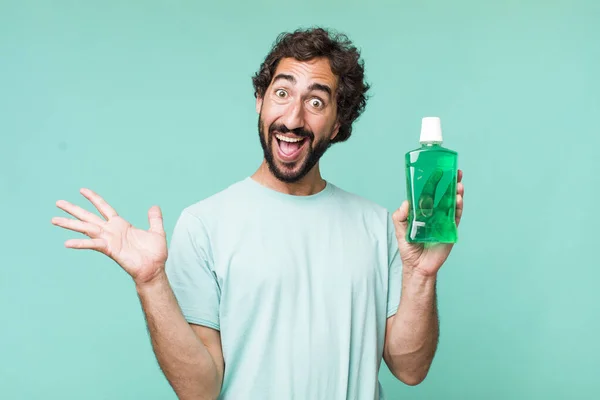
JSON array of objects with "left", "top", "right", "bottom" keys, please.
[{"left": 252, "top": 27, "right": 370, "bottom": 143}]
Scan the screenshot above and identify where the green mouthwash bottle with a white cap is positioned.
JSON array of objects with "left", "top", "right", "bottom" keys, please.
[{"left": 406, "top": 117, "right": 458, "bottom": 243}]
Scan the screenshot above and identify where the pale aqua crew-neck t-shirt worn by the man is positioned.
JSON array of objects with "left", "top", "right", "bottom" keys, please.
[{"left": 166, "top": 177, "right": 401, "bottom": 400}]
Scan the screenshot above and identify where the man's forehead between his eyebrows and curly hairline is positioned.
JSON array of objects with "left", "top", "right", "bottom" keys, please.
[{"left": 273, "top": 57, "right": 337, "bottom": 90}]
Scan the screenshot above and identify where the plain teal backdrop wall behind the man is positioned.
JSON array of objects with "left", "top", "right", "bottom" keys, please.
[{"left": 0, "top": 0, "right": 600, "bottom": 400}]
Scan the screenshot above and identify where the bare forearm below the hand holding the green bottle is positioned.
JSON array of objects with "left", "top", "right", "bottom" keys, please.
[{"left": 386, "top": 272, "right": 439, "bottom": 385}]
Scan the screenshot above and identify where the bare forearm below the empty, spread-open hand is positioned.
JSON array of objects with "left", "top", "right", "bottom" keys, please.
[{"left": 136, "top": 274, "right": 221, "bottom": 399}]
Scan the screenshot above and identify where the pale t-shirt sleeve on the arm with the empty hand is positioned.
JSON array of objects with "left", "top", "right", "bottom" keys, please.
[{"left": 165, "top": 210, "right": 221, "bottom": 330}]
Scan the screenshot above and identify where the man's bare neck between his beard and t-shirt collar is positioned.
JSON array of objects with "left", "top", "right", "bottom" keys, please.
[{"left": 252, "top": 160, "right": 325, "bottom": 196}]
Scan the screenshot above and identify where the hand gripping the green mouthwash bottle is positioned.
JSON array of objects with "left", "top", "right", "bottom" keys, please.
[{"left": 392, "top": 170, "right": 464, "bottom": 276}]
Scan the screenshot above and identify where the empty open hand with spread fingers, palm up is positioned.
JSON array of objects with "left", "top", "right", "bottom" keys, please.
[{"left": 52, "top": 189, "right": 167, "bottom": 285}]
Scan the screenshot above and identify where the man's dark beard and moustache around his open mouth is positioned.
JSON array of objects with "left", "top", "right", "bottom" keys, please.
[{"left": 258, "top": 113, "right": 331, "bottom": 183}]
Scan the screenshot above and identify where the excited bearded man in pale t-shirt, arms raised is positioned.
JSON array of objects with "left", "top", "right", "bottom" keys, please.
[{"left": 53, "top": 29, "right": 463, "bottom": 400}]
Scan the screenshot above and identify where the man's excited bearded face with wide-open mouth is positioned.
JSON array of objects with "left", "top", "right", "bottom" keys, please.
[{"left": 256, "top": 58, "right": 339, "bottom": 183}]
